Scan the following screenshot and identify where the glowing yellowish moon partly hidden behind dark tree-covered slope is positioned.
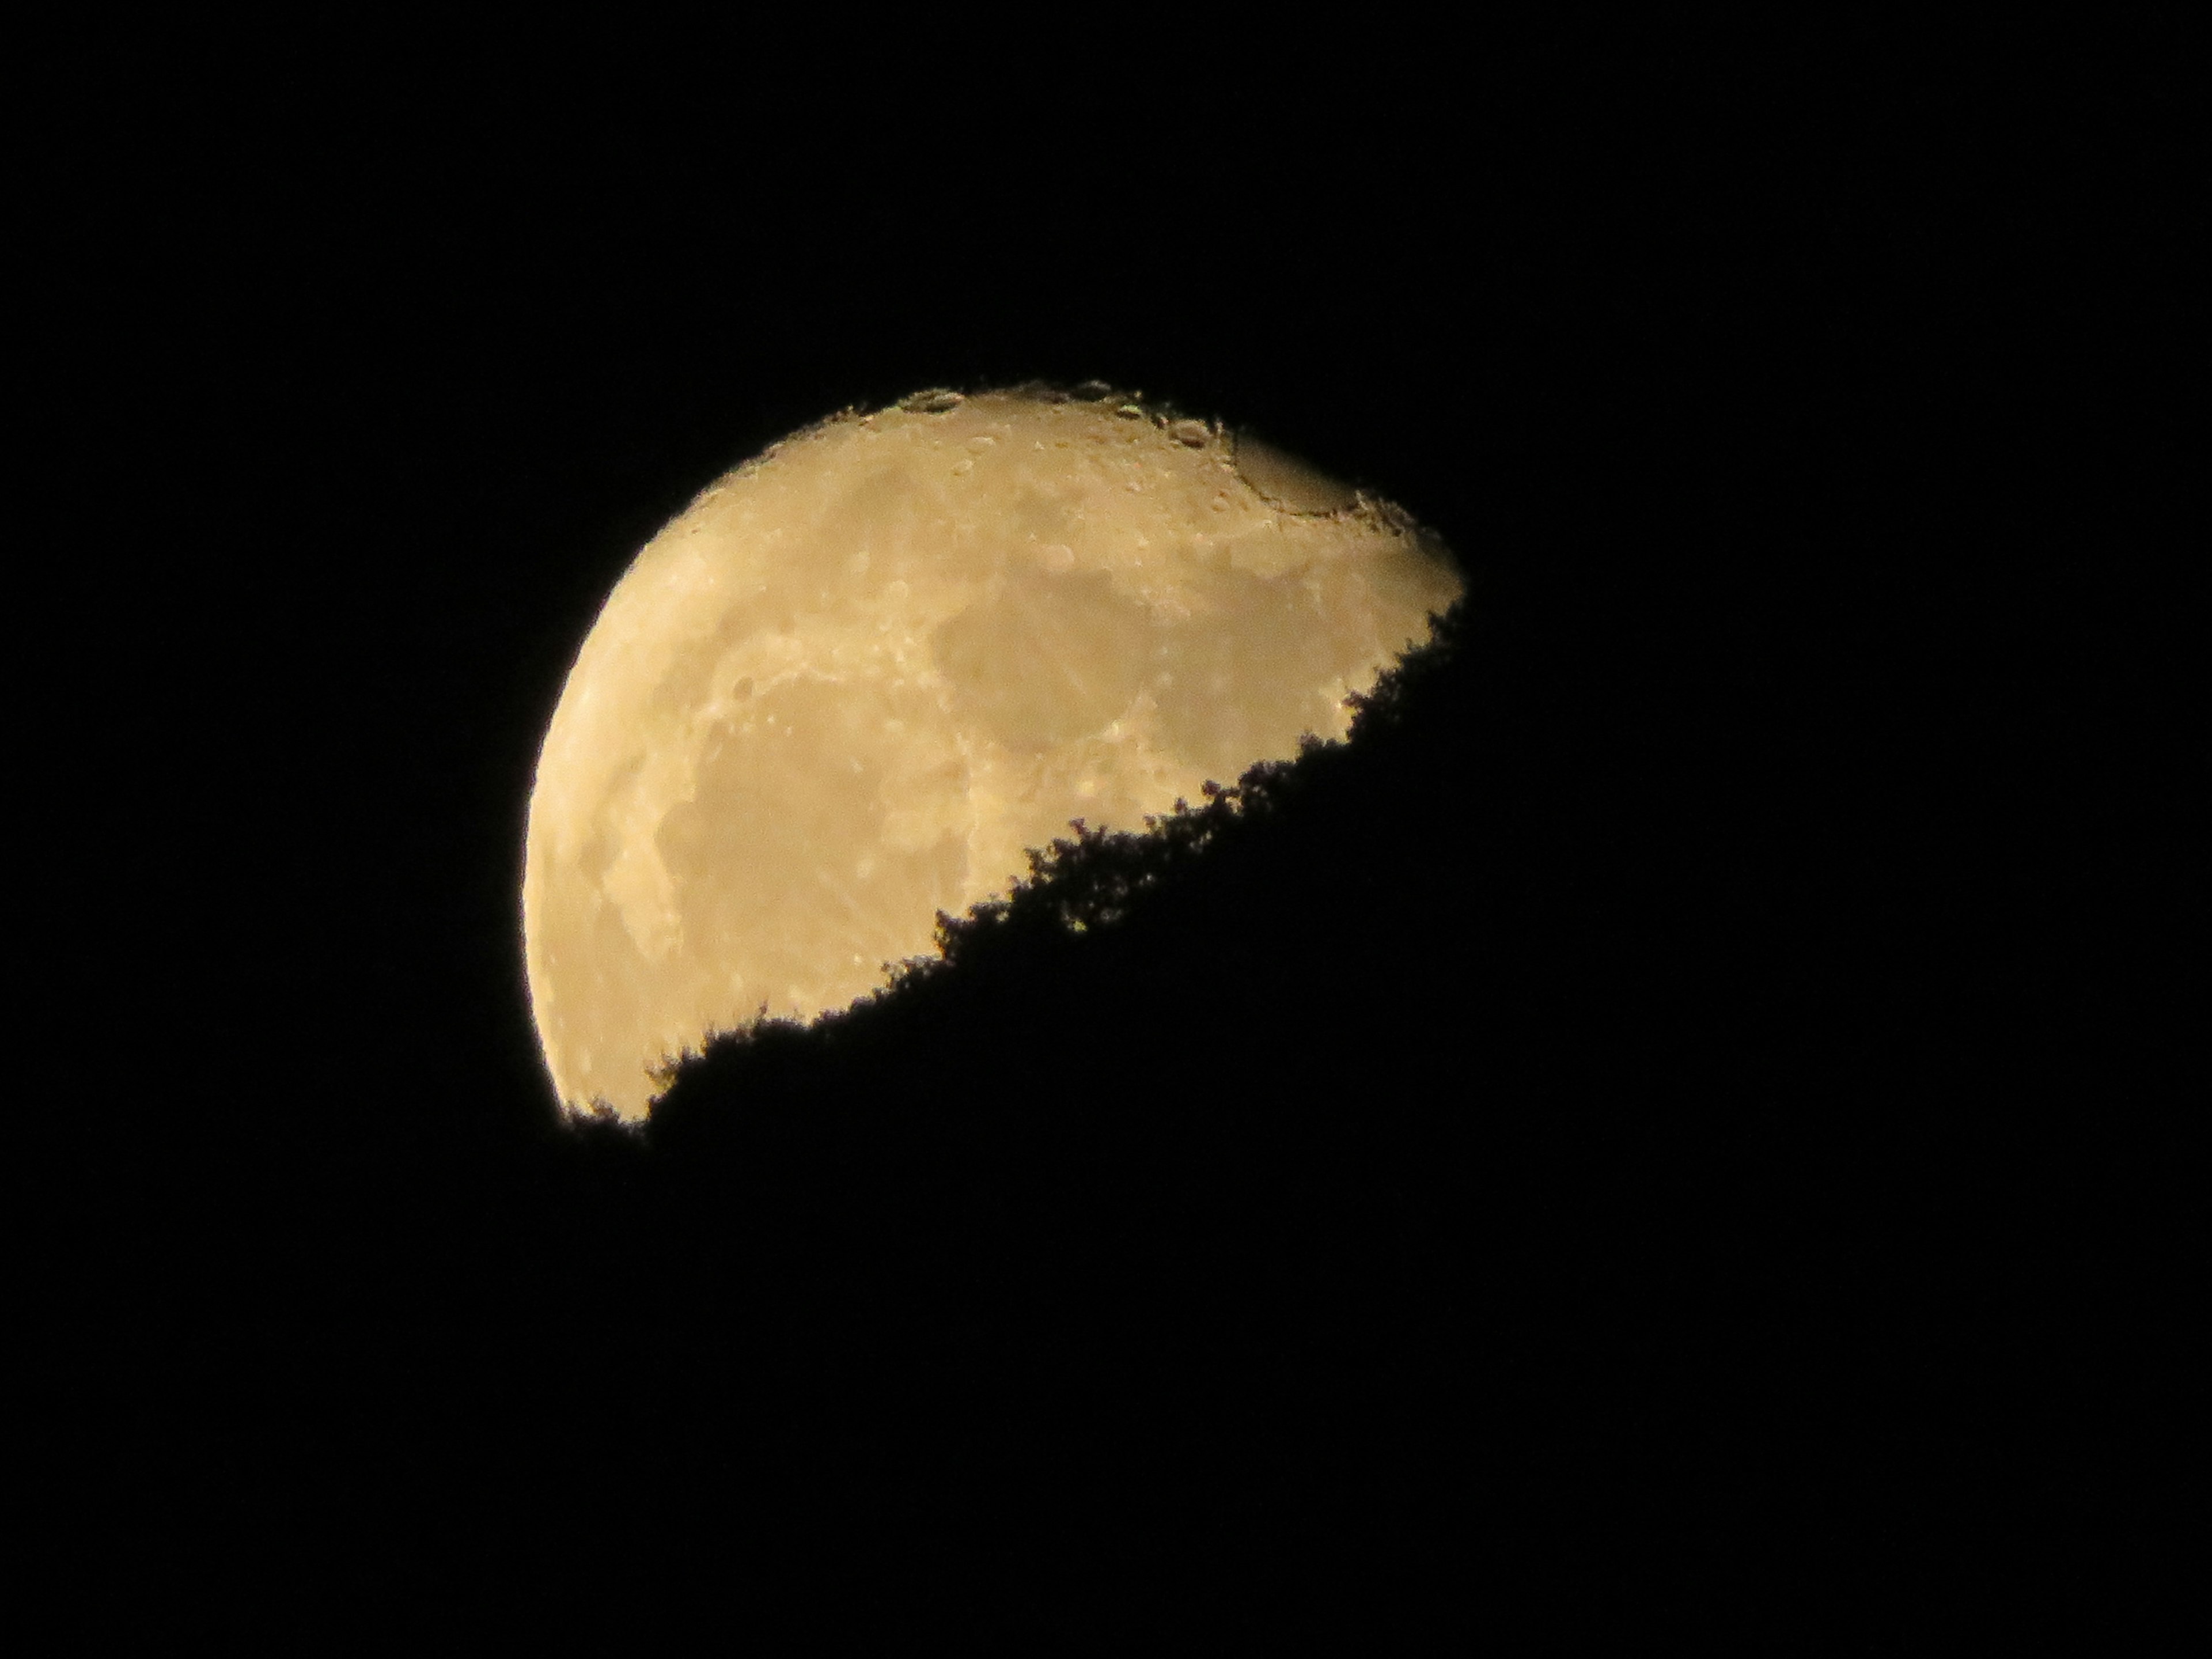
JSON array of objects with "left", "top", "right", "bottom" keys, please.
[{"left": 522, "top": 385, "right": 1462, "bottom": 1122}]
